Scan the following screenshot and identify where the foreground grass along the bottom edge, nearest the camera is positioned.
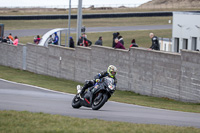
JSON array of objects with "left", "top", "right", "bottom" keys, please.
[{"left": 0, "top": 111, "right": 200, "bottom": 133}]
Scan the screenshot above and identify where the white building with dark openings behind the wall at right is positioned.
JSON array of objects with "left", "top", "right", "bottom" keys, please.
[{"left": 172, "top": 11, "right": 200, "bottom": 52}]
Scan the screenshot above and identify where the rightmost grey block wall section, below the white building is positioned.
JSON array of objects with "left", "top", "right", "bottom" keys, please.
[{"left": 180, "top": 50, "right": 200, "bottom": 102}]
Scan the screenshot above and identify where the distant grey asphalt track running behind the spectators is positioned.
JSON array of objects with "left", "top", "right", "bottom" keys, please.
[{"left": 5, "top": 25, "right": 172, "bottom": 37}]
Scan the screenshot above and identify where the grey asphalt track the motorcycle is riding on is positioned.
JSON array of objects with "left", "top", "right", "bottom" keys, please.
[{"left": 0, "top": 79, "right": 200, "bottom": 128}]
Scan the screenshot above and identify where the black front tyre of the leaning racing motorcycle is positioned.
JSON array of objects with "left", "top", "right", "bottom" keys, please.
[{"left": 92, "top": 94, "right": 108, "bottom": 110}]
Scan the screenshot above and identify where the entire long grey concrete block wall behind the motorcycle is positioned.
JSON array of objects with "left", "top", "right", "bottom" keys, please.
[{"left": 0, "top": 44, "right": 200, "bottom": 102}]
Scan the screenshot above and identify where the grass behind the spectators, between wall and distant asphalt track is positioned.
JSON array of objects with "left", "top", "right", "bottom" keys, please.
[{"left": 19, "top": 29, "right": 172, "bottom": 49}]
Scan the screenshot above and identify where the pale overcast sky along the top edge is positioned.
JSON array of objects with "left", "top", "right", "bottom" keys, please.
[{"left": 0, "top": 0, "right": 151, "bottom": 8}]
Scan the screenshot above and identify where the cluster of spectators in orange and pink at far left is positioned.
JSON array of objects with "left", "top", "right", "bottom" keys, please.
[{"left": 0, "top": 33, "right": 19, "bottom": 46}]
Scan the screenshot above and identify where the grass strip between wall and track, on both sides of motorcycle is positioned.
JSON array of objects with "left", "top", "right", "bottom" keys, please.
[{"left": 0, "top": 66, "right": 200, "bottom": 113}]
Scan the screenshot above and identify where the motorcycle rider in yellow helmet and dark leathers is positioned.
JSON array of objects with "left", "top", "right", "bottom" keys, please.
[{"left": 79, "top": 65, "right": 117, "bottom": 97}]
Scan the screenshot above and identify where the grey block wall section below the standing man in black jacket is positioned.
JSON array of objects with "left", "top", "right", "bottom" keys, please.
[{"left": 129, "top": 49, "right": 181, "bottom": 100}]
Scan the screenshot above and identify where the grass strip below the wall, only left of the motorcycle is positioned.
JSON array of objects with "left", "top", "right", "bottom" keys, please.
[{"left": 0, "top": 66, "right": 80, "bottom": 93}]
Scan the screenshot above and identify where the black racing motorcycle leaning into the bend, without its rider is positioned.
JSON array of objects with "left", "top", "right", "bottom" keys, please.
[{"left": 72, "top": 77, "right": 116, "bottom": 110}]
